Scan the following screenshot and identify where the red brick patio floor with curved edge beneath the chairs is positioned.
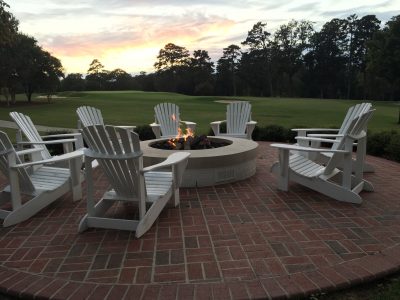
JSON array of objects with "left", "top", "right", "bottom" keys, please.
[{"left": 0, "top": 142, "right": 400, "bottom": 299}]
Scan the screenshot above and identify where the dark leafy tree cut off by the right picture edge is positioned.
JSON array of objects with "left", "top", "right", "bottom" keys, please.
[{"left": 367, "top": 15, "right": 400, "bottom": 100}]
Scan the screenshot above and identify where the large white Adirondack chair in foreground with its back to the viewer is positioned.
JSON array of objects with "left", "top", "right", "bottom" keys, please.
[{"left": 79, "top": 125, "right": 190, "bottom": 237}]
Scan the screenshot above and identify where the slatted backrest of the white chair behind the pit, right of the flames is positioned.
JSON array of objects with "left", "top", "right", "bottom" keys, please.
[{"left": 226, "top": 101, "right": 251, "bottom": 134}]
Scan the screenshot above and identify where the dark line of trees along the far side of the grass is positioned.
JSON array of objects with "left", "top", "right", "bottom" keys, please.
[{"left": 0, "top": 0, "right": 400, "bottom": 101}]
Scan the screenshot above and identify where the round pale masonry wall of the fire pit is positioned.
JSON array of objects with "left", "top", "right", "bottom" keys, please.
[{"left": 140, "top": 136, "right": 258, "bottom": 187}]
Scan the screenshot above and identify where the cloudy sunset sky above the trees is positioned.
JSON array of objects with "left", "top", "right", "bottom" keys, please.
[{"left": 5, "top": 0, "right": 400, "bottom": 74}]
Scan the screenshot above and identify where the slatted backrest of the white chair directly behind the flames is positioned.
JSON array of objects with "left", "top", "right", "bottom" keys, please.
[{"left": 154, "top": 103, "right": 180, "bottom": 135}]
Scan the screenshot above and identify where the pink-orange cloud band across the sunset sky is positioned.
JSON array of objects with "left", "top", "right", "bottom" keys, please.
[{"left": 37, "top": 14, "right": 235, "bottom": 56}]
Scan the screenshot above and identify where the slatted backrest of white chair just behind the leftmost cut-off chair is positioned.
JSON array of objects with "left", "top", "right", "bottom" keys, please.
[{"left": 10, "top": 111, "right": 51, "bottom": 159}]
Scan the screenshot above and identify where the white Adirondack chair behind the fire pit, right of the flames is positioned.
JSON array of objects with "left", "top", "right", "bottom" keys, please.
[{"left": 210, "top": 101, "right": 257, "bottom": 140}]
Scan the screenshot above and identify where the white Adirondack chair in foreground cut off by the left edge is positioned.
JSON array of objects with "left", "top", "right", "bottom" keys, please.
[{"left": 0, "top": 131, "right": 83, "bottom": 227}]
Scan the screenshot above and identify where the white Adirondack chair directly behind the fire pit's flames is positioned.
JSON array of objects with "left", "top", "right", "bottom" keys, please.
[{"left": 150, "top": 103, "right": 196, "bottom": 139}]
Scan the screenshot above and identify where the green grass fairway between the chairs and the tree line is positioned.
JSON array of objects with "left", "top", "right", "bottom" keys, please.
[{"left": 0, "top": 91, "right": 400, "bottom": 133}]
